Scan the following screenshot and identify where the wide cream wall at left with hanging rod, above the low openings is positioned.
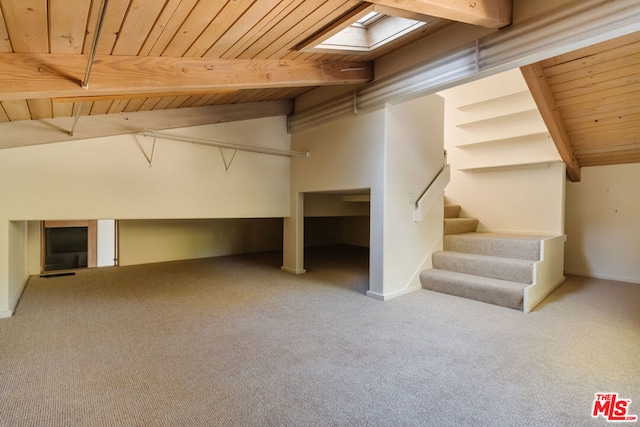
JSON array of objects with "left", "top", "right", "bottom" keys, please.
[{"left": 0, "top": 116, "right": 290, "bottom": 312}]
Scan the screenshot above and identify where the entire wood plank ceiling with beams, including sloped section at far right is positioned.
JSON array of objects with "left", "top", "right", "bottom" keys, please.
[{"left": 0, "top": 0, "right": 640, "bottom": 179}]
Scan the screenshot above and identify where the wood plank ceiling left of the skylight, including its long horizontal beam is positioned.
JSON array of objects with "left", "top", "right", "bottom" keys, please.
[{"left": 0, "top": 0, "right": 450, "bottom": 122}]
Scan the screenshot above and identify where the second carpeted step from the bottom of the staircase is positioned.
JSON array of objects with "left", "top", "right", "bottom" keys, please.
[{"left": 432, "top": 251, "right": 535, "bottom": 284}]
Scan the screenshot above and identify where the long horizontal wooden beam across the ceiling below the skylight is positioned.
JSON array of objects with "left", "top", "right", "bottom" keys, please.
[{"left": 0, "top": 53, "right": 373, "bottom": 101}]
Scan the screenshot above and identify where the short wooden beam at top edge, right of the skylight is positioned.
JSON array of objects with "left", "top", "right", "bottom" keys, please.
[{"left": 369, "top": 0, "right": 512, "bottom": 28}]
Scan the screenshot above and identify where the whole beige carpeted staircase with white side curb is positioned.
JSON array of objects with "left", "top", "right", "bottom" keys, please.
[{"left": 420, "top": 205, "right": 564, "bottom": 311}]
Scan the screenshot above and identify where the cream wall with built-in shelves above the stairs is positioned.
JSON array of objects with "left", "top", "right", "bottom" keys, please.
[{"left": 440, "top": 70, "right": 565, "bottom": 234}]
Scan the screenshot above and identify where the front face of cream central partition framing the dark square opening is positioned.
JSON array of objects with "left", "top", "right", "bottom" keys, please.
[{"left": 283, "top": 110, "right": 385, "bottom": 278}]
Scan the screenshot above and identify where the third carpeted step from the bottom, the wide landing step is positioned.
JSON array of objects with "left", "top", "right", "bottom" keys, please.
[{"left": 443, "top": 232, "right": 545, "bottom": 261}]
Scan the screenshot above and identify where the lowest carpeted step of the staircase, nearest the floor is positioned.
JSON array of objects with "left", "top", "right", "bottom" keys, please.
[{"left": 420, "top": 269, "right": 528, "bottom": 310}]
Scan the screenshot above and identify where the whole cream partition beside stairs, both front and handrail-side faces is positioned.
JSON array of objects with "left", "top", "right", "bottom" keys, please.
[{"left": 283, "top": 95, "right": 443, "bottom": 299}]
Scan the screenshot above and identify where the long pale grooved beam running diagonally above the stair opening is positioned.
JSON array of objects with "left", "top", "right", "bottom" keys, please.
[{"left": 289, "top": 0, "right": 640, "bottom": 138}]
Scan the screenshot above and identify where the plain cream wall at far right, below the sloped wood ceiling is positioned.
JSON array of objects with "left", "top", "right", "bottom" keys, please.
[{"left": 565, "top": 163, "right": 640, "bottom": 283}]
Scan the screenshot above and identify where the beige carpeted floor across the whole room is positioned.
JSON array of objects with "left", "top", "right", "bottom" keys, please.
[{"left": 0, "top": 247, "right": 640, "bottom": 426}]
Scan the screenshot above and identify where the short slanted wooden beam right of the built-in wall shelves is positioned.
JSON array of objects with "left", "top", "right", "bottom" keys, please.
[{"left": 520, "top": 62, "right": 580, "bottom": 182}]
